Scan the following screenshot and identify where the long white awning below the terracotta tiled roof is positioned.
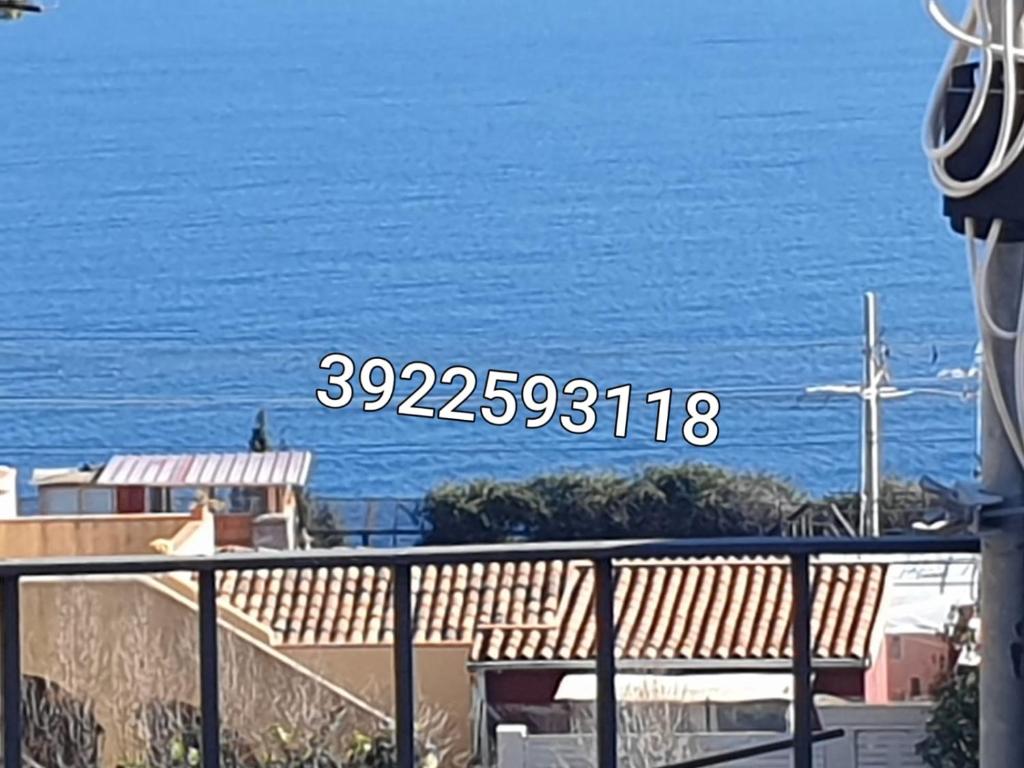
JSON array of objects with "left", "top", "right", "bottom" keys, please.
[{"left": 555, "top": 673, "right": 793, "bottom": 703}]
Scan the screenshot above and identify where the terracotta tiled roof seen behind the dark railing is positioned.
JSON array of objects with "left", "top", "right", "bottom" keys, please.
[{"left": 219, "top": 559, "right": 886, "bottom": 662}]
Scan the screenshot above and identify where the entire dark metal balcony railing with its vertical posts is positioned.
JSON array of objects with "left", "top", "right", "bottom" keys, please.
[{"left": 0, "top": 537, "right": 979, "bottom": 768}]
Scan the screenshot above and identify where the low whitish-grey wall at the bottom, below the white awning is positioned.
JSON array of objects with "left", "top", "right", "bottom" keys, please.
[{"left": 497, "top": 705, "right": 928, "bottom": 768}]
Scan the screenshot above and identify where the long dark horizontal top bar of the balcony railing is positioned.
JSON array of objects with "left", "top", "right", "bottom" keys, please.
[{"left": 0, "top": 537, "right": 980, "bottom": 577}]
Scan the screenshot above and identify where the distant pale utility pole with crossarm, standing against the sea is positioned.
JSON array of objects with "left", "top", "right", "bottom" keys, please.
[{"left": 804, "top": 292, "right": 913, "bottom": 536}]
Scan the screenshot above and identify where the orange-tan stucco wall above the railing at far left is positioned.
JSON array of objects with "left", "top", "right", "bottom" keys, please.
[{"left": 0, "top": 514, "right": 203, "bottom": 557}]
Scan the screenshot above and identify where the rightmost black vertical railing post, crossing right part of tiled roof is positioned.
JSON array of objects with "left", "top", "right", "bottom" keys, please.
[{"left": 791, "top": 554, "right": 814, "bottom": 768}]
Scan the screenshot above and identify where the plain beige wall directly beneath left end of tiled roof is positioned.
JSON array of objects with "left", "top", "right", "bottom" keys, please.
[{"left": 279, "top": 643, "right": 472, "bottom": 765}]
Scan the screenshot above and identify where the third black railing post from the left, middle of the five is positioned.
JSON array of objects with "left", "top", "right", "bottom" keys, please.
[{"left": 392, "top": 563, "right": 416, "bottom": 768}]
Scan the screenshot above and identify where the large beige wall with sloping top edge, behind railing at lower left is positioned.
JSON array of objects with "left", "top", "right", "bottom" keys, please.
[{"left": 6, "top": 581, "right": 386, "bottom": 767}]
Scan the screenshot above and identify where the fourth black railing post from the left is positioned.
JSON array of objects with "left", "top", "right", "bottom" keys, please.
[{"left": 594, "top": 558, "right": 618, "bottom": 768}]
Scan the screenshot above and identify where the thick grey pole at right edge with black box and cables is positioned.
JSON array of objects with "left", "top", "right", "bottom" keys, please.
[{"left": 924, "top": 0, "right": 1024, "bottom": 757}]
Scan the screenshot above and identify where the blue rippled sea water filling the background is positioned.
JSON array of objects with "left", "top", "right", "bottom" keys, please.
[{"left": 0, "top": 0, "right": 975, "bottom": 496}]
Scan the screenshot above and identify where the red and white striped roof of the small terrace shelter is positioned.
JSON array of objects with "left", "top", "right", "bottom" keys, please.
[{"left": 96, "top": 451, "right": 312, "bottom": 487}]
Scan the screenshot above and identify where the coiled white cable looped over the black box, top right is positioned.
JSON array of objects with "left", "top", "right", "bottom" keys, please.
[{"left": 922, "top": 0, "right": 1024, "bottom": 198}]
